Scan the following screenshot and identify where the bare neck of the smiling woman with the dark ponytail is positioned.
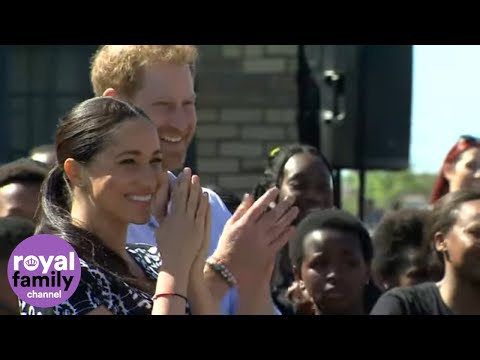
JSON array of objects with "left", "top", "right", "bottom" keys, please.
[{"left": 71, "top": 201, "right": 128, "bottom": 260}]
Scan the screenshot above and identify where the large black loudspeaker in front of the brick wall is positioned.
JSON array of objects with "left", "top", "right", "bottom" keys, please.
[{"left": 304, "top": 45, "right": 413, "bottom": 170}]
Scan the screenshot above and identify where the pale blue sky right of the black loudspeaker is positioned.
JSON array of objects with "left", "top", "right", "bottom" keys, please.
[{"left": 410, "top": 45, "right": 480, "bottom": 173}]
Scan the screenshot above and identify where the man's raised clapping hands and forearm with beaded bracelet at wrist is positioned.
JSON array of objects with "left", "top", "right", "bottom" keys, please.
[{"left": 205, "top": 189, "right": 298, "bottom": 314}]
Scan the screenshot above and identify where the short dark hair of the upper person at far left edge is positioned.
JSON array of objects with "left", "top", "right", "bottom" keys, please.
[{"left": 0, "top": 158, "right": 48, "bottom": 187}]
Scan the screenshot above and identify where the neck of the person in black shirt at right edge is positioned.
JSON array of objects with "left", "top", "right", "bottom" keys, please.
[{"left": 437, "top": 266, "right": 480, "bottom": 315}]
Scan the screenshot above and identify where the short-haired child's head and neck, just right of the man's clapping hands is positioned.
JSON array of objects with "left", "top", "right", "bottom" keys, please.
[{"left": 290, "top": 209, "right": 373, "bottom": 315}]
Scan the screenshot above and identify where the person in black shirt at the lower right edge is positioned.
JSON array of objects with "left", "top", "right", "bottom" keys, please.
[{"left": 371, "top": 190, "right": 480, "bottom": 315}]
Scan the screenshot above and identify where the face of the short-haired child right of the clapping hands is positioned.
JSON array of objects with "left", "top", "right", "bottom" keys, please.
[{"left": 296, "top": 229, "right": 370, "bottom": 315}]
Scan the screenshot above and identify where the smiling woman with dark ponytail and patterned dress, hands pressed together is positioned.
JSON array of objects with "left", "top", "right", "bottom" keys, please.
[{"left": 22, "top": 97, "right": 209, "bottom": 315}]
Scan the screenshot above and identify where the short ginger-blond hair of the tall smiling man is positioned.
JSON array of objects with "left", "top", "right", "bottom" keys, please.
[{"left": 90, "top": 45, "right": 198, "bottom": 98}]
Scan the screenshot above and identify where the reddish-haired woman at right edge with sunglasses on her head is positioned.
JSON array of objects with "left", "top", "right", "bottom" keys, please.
[{"left": 430, "top": 135, "right": 480, "bottom": 204}]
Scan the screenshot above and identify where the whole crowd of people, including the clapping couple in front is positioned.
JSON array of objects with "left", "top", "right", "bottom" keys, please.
[{"left": 0, "top": 45, "right": 480, "bottom": 315}]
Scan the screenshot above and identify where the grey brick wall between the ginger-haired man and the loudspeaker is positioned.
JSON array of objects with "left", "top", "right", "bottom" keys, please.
[{"left": 197, "top": 45, "right": 298, "bottom": 194}]
